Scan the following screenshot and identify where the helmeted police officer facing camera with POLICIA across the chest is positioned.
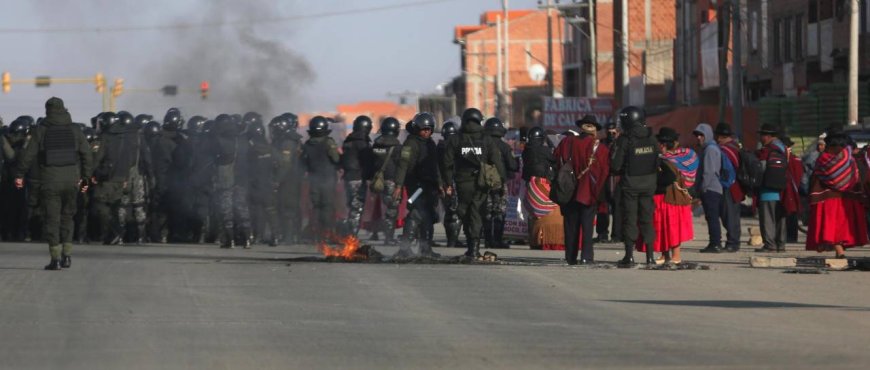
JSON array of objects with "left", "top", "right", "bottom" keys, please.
[{"left": 442, "top": 108, "right": 506, "bottom": 258}]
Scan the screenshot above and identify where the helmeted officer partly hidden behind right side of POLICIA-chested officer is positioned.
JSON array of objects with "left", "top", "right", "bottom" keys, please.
[{"left": 483, "top": 117, "right": 520, "bottom": 248}]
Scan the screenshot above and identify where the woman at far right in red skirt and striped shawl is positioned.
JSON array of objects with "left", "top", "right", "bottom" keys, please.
[{"left": 807, "top": 134, "right": 867, "bottom": 258}]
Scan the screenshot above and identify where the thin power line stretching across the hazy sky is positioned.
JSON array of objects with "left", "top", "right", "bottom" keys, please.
[{"left": 0, "top": 0, "right": 459, "bottom": 34}]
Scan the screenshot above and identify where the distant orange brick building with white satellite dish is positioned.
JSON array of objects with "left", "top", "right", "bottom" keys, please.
[{"left": 448, "top": 10, "right": 564, "bottom": 123}]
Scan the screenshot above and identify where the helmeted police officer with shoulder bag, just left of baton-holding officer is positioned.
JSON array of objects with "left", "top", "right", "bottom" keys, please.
[{"left": 372, "top": 117, "right": 402, "bottom": 245}]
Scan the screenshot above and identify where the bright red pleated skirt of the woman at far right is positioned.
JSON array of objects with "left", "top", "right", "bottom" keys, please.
[{"left": 807, "top": 198, "right": 867, "bottom": 252}]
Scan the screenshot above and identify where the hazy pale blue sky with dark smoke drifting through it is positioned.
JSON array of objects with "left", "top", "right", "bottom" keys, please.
[{"left": 0, "top": 0, "right": 537, "bottom": 123}]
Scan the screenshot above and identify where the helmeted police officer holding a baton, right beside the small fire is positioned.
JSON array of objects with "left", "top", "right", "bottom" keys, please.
[{"left": 393, "top": 112, "right": 442, "bottom": 258}]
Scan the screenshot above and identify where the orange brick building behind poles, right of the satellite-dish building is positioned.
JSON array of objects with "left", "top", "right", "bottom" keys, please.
[{"left": 557, "top": 0, "right": 676, "bottom": 107}]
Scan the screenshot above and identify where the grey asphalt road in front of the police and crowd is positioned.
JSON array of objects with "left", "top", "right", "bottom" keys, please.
[{"left": 0, "top": 230, "right": 870, "bottom": 370}]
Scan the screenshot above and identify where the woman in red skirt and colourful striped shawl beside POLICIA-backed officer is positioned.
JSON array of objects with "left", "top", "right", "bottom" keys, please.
[{"left": 636, "top": 127, "right": 699, "bottom": 264}]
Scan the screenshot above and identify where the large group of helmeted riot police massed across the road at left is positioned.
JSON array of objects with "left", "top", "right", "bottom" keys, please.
[{"left": 0, "top": 98, "right": 518, "bottom": 269}]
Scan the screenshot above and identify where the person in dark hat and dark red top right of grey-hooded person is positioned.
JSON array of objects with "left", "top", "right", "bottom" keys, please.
[{"left": 715, "top": 122, "right": 746, "bottom": 253}]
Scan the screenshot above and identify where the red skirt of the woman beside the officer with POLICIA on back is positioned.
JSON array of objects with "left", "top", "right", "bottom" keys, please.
[{"left": 635, "top": 194, "right": 695, "bottom": 252}]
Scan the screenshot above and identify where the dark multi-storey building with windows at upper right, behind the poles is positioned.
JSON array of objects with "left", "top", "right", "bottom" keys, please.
[{"left": 675, "top": 0, "right": 870, "bottom": 105}]
